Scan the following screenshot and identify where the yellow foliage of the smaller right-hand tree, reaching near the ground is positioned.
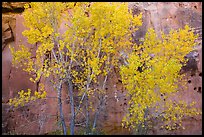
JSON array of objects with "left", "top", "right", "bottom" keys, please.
[{"left": 120, "top": 26, "right": 198, "bottom": 130}]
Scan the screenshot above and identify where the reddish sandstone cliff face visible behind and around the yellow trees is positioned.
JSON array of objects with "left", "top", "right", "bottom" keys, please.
[{"left": 2, "top": 2, "right": 202, "bottom": 134}]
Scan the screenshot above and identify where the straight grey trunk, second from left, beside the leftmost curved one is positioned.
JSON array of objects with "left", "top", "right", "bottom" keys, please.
[{"left": 68, "top": 79, "right": 75, "bottom": 135}]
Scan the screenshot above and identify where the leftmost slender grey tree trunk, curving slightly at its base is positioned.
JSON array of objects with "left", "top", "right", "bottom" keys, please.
[{"left": 58, "top": 83, "right": 67, "bottom": 135}]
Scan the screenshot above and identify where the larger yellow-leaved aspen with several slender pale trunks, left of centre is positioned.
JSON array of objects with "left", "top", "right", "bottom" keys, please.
[{"left": 10, "top": 2, "right": 142, "bottom": 135}]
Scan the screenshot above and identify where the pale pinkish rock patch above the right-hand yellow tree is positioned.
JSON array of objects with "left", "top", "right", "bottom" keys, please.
[{"left": 129, "top": 2, "right": 202, "bottom": 40}]
